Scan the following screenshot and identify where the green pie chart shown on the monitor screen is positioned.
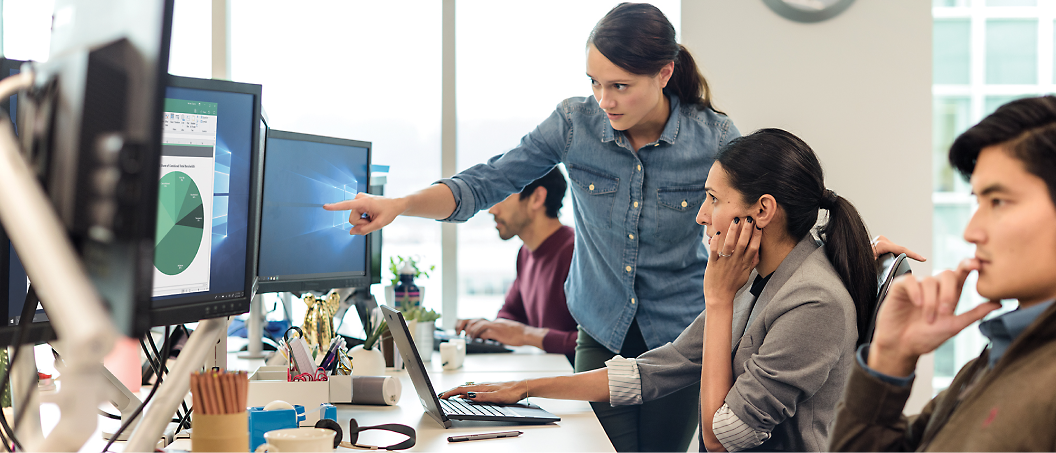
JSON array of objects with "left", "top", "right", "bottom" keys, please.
[{"left": 154, "top": 171, "right": 205, "bottom": 276}]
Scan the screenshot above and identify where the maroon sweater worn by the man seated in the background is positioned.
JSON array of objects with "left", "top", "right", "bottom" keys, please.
[{"left": 497, "top": 226, "right": 578, "bottom": 359}]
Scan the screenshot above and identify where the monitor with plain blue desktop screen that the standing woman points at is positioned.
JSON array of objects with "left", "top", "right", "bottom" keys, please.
[{"left": 258, "top": 129, "right": 371, "bottom": 292}]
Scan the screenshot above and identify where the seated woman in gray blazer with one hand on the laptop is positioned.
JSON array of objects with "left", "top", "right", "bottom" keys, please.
[{"left": 441, "top": 129, "right": 876, "bottom": 452}]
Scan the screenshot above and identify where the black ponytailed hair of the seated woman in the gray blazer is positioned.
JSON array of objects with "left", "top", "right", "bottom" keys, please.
[{"left": 717, "top": 129, "right": 878, "bottom": 342}]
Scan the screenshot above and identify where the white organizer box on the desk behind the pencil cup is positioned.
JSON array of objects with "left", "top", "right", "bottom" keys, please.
[{"left": 246, "top": 366, "right": 352, "bottom": 427}]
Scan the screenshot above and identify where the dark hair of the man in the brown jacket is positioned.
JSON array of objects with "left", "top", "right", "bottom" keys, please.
[{"left": 949, "top": 96, "right": 1056, "bottom": 204}]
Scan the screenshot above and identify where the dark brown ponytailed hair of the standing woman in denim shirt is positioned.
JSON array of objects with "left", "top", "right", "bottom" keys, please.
[{"left": 587, "top": 3, "right": 721, "bottom": 113}]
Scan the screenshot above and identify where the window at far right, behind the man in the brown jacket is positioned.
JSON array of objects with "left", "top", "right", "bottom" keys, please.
[{"left": 931, "top": 0, "right": 1056, "bottom": 393}]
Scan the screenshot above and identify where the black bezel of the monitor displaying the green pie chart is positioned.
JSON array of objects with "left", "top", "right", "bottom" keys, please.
[{"left": 150, "top": 75, "right": 263, "bottom": 325}]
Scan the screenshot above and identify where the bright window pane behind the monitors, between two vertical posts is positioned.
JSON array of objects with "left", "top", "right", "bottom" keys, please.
[{"left": 230, "top": 0, "right": 441, "bottom": 312}]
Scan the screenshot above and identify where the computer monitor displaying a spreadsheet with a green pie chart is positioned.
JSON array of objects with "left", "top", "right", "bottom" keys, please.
[{"left": 151, "top": 76, "right": 261, "bottom": 325}]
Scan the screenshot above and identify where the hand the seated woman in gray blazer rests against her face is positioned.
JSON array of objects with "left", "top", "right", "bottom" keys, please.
[{"left": 704, "top": 218, "right": 762, "bottom": 307}]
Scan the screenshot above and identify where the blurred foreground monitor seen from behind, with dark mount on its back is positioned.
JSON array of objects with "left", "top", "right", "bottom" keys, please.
[{"left": 7, "top": 0, "right": 173, "bottom": 337}]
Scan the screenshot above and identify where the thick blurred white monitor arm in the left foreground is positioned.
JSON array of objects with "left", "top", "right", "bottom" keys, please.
[{"left": 0, "top": 88, "right": 116, "bottom": 453}]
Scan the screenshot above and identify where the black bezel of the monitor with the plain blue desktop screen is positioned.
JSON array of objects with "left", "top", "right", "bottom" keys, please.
[{"left": 257, "top": 129, "right": 374, "bottom": 294}]
